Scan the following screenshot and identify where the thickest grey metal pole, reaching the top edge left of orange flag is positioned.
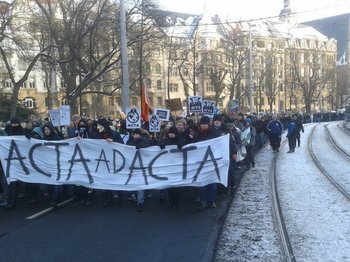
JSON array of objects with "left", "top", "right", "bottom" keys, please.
[{"left": 120, "top": 0, "right": 130, "bottom": 112}]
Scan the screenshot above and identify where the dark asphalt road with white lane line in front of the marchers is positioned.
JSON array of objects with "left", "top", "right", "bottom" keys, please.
[{"left": 0, "top": 185, "right": 235, "bottom": 262}]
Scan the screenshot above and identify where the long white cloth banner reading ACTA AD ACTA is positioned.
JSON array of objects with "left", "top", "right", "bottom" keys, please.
[{"left": 0, "top": 135, "right": 229, "bottom": 190}]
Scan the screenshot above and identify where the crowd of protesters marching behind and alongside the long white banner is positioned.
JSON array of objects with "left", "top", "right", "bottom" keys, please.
[{"left": 0, "top": 109, "right": 344, "bottom": 211}]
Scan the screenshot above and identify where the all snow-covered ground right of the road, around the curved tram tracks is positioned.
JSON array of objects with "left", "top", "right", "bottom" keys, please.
[{"left": 215, "top": 122, "right": 350, "bottom": 262}]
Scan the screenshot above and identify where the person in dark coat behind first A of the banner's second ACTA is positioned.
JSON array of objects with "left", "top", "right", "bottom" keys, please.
[{"left": 126, "top": 128, "right": 152, "bottom": 211}]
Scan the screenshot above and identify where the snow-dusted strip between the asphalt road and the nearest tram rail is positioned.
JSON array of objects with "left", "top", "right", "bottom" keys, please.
[{"left": 215, "top": 141, "right": 281, "bottom": 261}]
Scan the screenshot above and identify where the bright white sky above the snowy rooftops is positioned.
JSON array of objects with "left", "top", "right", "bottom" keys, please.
[{"left": 157, "top": 0, "right": 350, "bottom": 22}]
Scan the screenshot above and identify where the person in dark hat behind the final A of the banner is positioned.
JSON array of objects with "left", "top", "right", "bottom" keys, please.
[{"left": 195, "top": 116, "right": 219, "bottom": 210}]
